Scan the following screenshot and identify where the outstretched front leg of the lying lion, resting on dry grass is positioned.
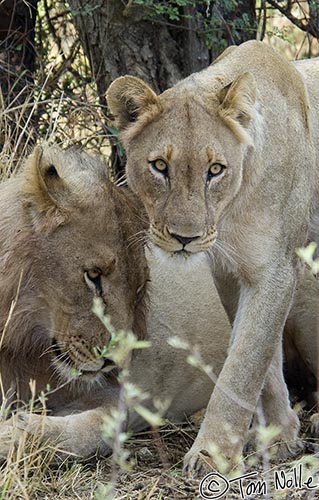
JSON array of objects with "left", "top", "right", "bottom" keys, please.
[{"left": 16, "top": 407, "right": 109, "bottom": 459}]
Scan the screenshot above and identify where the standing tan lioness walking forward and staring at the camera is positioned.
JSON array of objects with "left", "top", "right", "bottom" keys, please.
[{"left": 107, "top": 41, "right": 319, "bottom": 475}]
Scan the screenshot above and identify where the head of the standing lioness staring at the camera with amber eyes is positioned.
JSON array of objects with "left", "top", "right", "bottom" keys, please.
[{"left": 107, "top": 68, "right": 256, "bottom": 253}]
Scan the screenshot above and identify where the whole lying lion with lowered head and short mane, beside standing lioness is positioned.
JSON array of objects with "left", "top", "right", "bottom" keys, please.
[{"left": 0, "top": 146, "right": 316, "bottom": 458}]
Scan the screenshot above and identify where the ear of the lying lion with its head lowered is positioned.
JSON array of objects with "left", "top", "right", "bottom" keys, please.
[{"left": 24, "top": 146, "right": 69, "bottom": 222}]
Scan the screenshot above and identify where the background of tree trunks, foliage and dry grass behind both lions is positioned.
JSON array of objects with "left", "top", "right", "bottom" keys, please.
[{"left": 0, "top": 0, "right": 319, "bottom": 180}]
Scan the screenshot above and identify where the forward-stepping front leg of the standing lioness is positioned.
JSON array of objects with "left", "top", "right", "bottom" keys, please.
[{"left": 184, "top": 263, "right": 296, "bottom": 475}]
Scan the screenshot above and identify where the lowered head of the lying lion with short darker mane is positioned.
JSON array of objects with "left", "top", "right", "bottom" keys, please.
[{"left": 0, "top": 146, "right": 147, "bottom": 390}]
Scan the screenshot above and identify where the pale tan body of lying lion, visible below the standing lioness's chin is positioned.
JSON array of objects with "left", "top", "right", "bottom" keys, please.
[{"left": 131, "top": 246, "right": 230, "bottom": 421}]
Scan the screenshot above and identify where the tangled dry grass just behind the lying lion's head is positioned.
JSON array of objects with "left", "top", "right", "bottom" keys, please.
[{"left": 0, "top": 62, "right": 110, "bottom": 179}]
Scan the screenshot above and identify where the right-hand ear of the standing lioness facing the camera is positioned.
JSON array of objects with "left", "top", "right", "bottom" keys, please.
[{"left": 219, "top": 73, "right": 257, "bottom": 143}]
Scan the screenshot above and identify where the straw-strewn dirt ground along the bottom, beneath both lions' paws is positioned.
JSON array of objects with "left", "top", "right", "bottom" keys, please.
[{"left": 0, "top": 412, "right": 319, "bottom": 500}]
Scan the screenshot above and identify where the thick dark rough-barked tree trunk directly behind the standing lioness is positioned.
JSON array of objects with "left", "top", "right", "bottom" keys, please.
[{"left": 69, "top": 0, "right": 256, "bottom": 177}]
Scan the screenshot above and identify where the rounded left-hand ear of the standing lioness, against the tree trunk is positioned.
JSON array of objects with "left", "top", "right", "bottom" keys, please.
[{"left": 106, "top": 76, "right": 160, "bottom": 130}]
